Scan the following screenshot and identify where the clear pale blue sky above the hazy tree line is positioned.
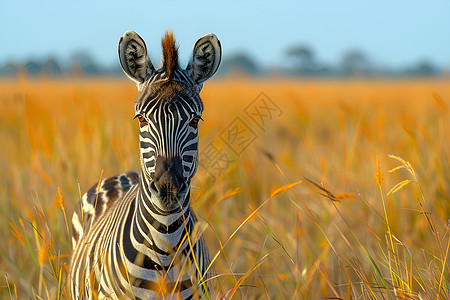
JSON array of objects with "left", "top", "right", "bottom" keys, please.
[{"left": 0, "top": 0, "right": 450, "bottom": 68}]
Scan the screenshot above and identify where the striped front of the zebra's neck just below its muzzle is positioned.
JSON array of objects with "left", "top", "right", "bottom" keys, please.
[{"left": 131, "top": 174, "right": 194, "bottom": 253}]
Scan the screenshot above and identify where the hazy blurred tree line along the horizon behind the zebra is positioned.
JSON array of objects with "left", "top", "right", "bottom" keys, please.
[{"left": 0, "top": 45, "right": 446, "bottom": 78}]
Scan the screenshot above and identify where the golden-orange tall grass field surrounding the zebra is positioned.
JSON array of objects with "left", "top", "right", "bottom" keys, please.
[{"left": 0, "top": 78, "right": 450, "bottom": 299}]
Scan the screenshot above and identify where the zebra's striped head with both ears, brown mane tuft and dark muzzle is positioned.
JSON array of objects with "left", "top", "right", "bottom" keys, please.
[{"left": 119, "top": 31, "right": 221, "bottom": 213}]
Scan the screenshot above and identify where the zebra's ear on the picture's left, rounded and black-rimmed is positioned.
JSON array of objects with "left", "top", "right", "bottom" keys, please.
[{"left": 119, "top": 31, "right": 155, "bottom": 88}]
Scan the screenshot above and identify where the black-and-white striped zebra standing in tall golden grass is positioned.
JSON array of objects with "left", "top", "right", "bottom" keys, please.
[{"left": 69, "top": 31, "right": 222, "bottom": 299}]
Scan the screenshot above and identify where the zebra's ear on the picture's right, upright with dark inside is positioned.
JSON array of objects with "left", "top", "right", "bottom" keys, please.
[{"left": 186, "top": 33, "right": 222, "bottom": 87}]
